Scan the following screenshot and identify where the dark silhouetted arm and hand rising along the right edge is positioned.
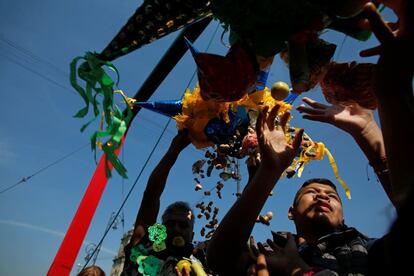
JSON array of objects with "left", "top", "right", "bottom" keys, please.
[{"left": 361, "top": 0, "right": 414, "bottom": 207}]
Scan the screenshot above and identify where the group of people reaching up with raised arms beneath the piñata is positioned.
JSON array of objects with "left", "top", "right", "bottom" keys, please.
[{"left": 88, "top": 0, "right": 414, "bottom": 276}]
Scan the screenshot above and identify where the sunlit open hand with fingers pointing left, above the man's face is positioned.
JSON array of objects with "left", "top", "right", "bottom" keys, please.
[{"left": 296, "top": 97, "right": 376, "bottom": 136}]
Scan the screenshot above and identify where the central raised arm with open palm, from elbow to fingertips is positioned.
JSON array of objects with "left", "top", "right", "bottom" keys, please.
[{"left": 207, "top": 106, "right": 303, "bottom": 275}]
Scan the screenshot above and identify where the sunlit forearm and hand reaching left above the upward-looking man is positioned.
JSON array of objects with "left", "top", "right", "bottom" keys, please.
[{"left": 297, "top": 97, "right": 394, "bottom": 203}]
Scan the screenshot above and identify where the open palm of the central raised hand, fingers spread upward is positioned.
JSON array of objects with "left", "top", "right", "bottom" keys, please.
[{"left": 256, "top": 105, "right": 303, "bottom": 171}]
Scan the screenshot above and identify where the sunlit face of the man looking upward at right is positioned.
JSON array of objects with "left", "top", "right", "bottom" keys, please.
[{"left": 288, "top": 183, "right": 343, "bottom": 229}]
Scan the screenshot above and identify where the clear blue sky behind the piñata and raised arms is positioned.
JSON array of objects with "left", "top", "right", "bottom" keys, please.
[{"left": 0, "top": 0, "right": 394, "bottom": 275}]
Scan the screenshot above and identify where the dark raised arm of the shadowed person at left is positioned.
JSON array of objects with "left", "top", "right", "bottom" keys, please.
[{"left": 130, "top": 132, "right": 190, "bottom": 246}]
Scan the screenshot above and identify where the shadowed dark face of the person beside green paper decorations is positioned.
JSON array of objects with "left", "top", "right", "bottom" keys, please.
[{"left": 163, "top": 212, "right": 194, "bottom": 247}]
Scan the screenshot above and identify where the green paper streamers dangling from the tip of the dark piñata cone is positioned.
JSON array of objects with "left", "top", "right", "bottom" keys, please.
[{"left": 70, "top": 52, "right": 132, "bottom": 178}]
